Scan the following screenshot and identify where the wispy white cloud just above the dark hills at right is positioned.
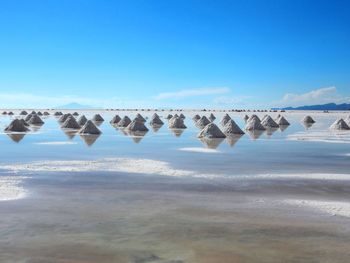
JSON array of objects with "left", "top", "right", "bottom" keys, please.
[{"left": 277, "top": 86, "right": 350, "bottom": 106}]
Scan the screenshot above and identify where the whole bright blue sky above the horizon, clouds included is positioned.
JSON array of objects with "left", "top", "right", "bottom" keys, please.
[{"left": 0, "top": 0, "right": 350, "bottom": 108}]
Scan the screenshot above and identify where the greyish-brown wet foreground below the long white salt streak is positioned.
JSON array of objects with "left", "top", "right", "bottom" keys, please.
[{"left": 0, "top": 173, "right": 350, "bottom": 263}]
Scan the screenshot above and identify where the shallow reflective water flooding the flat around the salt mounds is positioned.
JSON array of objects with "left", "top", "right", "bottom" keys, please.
[{"left": 0, "top": 112, "right": 350, "bottom": 262}]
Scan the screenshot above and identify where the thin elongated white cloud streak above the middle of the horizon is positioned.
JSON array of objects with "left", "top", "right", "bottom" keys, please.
[{"left": 154, "top": 87, "right": 230, "bottom": 100}]
